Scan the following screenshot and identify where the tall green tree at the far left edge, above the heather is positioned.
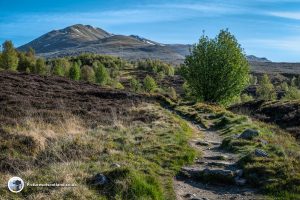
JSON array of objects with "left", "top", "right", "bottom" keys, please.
[{"left": 0, "top": 41, "right": 19, "bottom": 71}]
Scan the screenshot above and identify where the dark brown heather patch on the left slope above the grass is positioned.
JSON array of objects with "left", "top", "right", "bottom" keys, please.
[{"left": 0, "top": 72, "right": 149, "bottom": 124}]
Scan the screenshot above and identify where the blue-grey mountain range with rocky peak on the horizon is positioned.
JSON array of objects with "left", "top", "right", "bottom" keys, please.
[{"left": 18, "top": 24, "right": 270, "bottom": 64}]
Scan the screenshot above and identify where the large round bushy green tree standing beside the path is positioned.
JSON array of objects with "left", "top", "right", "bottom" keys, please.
[{"left": 182, "top": 30, "right": 249, "bottom": 104}]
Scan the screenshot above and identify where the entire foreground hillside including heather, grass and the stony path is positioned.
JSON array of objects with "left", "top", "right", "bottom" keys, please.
[{"left": 0, "top": 71, "right": 300, "bottom": 200}]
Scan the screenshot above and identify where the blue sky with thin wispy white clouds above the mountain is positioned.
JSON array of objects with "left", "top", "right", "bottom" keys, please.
[{"left": 0, "top": 0, "right": 300, "bottom": 62}]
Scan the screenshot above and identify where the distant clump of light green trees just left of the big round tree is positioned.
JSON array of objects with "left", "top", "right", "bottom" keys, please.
[{"left": 137, "top": 59, "right": 175, "bottom": 76}]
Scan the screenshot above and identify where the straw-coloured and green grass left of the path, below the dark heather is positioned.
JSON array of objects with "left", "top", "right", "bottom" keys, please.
[{"left": 0, "top": 104, "right": 197, "bottom": 200}]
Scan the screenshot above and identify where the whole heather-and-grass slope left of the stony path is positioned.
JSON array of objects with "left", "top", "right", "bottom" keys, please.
[{"left": 0, "top": 72, "right": 196, "bottom": 200}]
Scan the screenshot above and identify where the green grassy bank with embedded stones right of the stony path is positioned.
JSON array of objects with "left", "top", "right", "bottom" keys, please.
[{"left": 175, "top": 103, "right": 300, "bottom": 199}]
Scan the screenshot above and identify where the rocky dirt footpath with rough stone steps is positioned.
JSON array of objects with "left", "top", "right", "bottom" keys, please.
[{"left": 174, "top": 123, "right": 264, "bottom": 200}]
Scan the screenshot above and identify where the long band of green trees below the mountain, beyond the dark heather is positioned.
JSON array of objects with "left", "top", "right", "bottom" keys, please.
[{"left": 0, "top": 41, "right": 177, "bottom": 97}]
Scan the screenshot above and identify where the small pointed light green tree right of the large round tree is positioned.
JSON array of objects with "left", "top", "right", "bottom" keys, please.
[{"left": 257, "top": 74, "right": 276, "bottom": 101}]
